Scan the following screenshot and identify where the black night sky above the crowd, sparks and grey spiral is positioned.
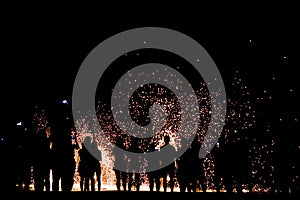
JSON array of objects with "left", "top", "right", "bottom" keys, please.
[{"left": 0, "top": 3, "right": 299, "bottom": 144}]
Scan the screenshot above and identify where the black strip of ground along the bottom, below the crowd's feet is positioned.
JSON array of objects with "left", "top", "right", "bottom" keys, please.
[{"left": 6, "top": 191, "right": 299, "bottom": 200}]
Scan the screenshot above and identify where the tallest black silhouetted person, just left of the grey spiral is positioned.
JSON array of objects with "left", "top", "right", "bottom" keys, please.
[{"left": 49, "top": 104, "right": 78, "bottom": 191}]
